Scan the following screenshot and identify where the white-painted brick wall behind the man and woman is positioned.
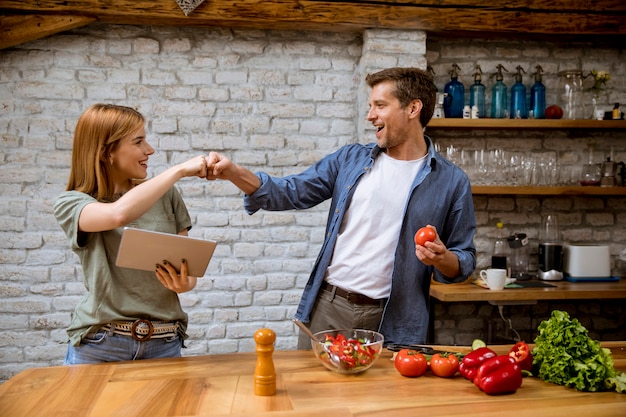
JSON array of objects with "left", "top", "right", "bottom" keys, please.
[{"left": 0, "top": 25, "right": 626, "bottom": 381}]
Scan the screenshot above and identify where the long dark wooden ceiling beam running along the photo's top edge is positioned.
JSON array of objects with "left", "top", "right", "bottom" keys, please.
[{"left": 0, "top": 0, "right": 626, "bottom": 49}]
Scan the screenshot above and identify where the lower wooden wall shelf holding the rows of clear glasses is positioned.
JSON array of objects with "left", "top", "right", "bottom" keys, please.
[{"left": 472, "top": 185, "right": 626, "bottom": 196}]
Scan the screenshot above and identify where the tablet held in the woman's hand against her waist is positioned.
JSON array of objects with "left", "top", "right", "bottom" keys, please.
[{"left": 115, "top": 227, "right": 217, "bottom": 277}]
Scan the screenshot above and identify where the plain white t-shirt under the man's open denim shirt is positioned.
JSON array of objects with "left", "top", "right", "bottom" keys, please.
[{"left": 326, "top": 153, "right": 426, "bottom": 299}]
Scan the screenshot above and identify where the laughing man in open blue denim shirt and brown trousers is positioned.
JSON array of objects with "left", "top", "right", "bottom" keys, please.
[{"left": 207, "top": 68, "right": 476, "bottom": 349}]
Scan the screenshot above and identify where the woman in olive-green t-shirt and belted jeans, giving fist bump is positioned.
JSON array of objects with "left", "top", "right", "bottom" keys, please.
[{"left": 54, "top": 104, "right": 207, "bottom": 365}]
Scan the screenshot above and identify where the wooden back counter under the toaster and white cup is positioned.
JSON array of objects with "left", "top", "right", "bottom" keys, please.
[{"left": 430, "top": 279, "right": 626, "bottom": 304}]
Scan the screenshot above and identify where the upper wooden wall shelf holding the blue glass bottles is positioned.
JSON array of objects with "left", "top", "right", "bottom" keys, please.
[{"left": 426, "top": 119, "right": 626, "bottom": 130}]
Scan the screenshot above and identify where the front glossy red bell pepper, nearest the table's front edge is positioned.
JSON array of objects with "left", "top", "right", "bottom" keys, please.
[{"left": 474, "top": 355, "right": 522, "bottom": 395}]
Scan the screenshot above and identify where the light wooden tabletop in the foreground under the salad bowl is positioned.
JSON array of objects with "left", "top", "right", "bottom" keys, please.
[{"left": 0, "top": 342, "right": 626, "bottom": 417}]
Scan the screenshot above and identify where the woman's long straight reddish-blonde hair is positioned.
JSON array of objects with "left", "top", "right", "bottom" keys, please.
[{"left": 66, "top": 104, "right": 145, "bottom": 200}]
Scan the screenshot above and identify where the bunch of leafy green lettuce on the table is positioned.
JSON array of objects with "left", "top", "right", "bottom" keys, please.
[{"left": 532, "top": 310, "right": 626, "bottom": 393}]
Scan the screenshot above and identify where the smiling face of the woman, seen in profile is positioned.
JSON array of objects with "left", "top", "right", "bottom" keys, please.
[{"left": 109, "top": 125, "right": 154, "bottom": 192}]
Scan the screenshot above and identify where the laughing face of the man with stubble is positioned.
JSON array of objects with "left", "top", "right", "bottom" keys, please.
[{"left": 367, "top": 81, "right": 422, "bottom": 156}]
